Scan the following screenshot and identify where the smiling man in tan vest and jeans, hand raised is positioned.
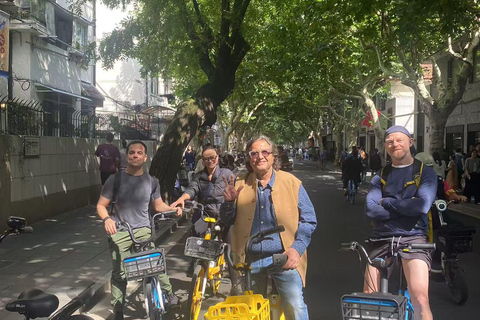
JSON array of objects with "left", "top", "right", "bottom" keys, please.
[{"left": 220, "top": 136, "right": 317, "bottom": 320}]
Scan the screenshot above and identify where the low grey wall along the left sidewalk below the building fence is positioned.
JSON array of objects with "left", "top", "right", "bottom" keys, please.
[{"left": 9, "top": 136, "right": 158, "bottom": 202}]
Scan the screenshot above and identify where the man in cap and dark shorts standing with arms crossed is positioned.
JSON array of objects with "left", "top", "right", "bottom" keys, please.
[{"left": 364, "top": 126, "right": 437, "bottom": 320}]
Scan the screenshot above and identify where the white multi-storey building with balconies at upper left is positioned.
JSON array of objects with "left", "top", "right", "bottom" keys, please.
[{"left": 0, "top": 0, "right": 104, "bottom": 137}]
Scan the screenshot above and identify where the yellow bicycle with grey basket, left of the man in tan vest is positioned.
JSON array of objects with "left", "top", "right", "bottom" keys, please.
[{"left": 184, "top": 201, "right": 226, "bottom": 320}]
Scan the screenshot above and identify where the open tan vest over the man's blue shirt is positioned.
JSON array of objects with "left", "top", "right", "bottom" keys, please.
[{"left": 232, "top": 171, "right": 307, "bottom": 286}]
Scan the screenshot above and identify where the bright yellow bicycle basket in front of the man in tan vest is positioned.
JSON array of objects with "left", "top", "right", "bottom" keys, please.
[{"left": 205, "top": 294, "right": 270, "bottom": 320}]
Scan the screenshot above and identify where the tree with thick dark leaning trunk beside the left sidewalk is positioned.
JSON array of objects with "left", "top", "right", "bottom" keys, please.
[{"left": 100, "top": 0, "right": 255, "bottom": 195}]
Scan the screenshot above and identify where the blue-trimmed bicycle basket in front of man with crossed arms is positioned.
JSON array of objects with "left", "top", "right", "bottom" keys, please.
[{"left": 342, "top": 293, "right": 407, "bottom": 320}]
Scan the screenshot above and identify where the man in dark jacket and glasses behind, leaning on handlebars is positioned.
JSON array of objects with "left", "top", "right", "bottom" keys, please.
[{"left": 171, "top": 144, "right": 233, "bottom": 276}]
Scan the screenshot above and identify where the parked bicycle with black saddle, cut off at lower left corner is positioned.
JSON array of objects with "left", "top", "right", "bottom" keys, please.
[{"left": 0, "top": 216, "right": 95, "bottom": 320}]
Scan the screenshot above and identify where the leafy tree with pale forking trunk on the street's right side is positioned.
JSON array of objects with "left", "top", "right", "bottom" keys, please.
[{"left": 326, "top": 0, "right": 480, "bottom": 152}]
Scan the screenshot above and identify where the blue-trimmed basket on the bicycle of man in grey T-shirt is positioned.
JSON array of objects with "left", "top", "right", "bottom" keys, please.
[{"left": 123, "top": 249, "right": 167, "bottom": 280}]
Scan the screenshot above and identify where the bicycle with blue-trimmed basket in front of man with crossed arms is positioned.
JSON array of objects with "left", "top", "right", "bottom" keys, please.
[{"left": 341, "top": 238, "right": 435, "bottom": 320}]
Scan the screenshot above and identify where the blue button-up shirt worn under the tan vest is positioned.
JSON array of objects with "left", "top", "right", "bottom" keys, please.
[{"left": 220, "top": 171, "right": 317, "bottom": 255}]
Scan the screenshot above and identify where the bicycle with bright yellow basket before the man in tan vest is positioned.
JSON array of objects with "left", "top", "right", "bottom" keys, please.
[{"left": 205, "top": 226, "right": 288, "bottom": 320}]
